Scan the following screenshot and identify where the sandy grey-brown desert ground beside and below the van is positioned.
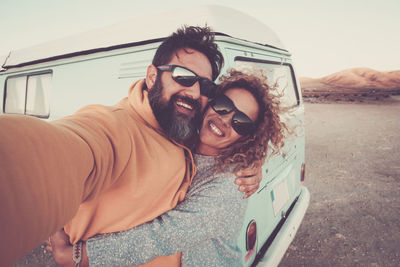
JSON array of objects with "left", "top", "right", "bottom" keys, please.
[{"left": 15, "top": 99, "right": 400, "bottom": 267}]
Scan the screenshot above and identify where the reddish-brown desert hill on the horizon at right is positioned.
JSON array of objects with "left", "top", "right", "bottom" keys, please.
[{"left": 300, "top": 68, "right": 400, "bottom": 101}]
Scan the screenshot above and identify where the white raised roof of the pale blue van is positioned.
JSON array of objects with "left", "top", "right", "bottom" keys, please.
[{"left": 3, "top": 5, "right": 286, "bottom": 68}]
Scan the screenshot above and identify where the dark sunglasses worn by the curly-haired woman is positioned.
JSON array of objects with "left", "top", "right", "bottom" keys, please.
[{"left": 208, "top": 95, "right": 256, "bottom": 136}]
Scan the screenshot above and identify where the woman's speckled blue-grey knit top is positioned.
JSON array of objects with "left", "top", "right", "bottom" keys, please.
[{"left": 86, "top": 155, "right": 247, "bottom": 267}]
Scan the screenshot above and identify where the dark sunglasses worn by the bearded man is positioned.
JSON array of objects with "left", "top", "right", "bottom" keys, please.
[{"left": 157, "top": 65, "right": 216, "bottom": 97}]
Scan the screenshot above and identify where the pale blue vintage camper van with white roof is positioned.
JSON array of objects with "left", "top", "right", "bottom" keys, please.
[{"left": 0, "top": 6, "right": 310, "bottom": 266}]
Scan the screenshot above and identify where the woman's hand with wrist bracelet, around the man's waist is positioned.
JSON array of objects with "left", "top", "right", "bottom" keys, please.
[{"left": 46, "top": 230, "right": 89, "bottom": 267}]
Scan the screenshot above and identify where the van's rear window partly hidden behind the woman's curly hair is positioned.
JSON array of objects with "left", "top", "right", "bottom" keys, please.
[{"left": 235, "top": 57, "right": 299, "bottom": 108}]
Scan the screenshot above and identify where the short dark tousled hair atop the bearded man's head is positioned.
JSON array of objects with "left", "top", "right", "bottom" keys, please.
[{"left": 152, "top": 26, "right": 224, "bottom": 80}]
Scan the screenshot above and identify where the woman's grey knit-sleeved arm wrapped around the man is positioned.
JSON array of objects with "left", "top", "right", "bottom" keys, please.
[{"left": 87, "top": 175, "right": 247, "bottom": 266}]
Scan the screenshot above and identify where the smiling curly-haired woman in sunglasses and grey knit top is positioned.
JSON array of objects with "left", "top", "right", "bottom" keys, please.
[{"left": 49, "top": 70, "right": 286, "bottom": 266}]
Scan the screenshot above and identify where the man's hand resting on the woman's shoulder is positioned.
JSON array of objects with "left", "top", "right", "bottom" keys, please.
[{"left": 235, "top": 166, "right": 262, "bottom": 198}]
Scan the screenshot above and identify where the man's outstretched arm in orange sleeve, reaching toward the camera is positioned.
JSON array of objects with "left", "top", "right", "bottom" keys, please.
[{"left": 0, "top": 109, "right": 129, "bottom": 266}]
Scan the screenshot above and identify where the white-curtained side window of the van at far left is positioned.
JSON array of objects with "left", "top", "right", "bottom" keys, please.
[{"left": 4, "top": 73, "right": 52, "bottom": 118}]
